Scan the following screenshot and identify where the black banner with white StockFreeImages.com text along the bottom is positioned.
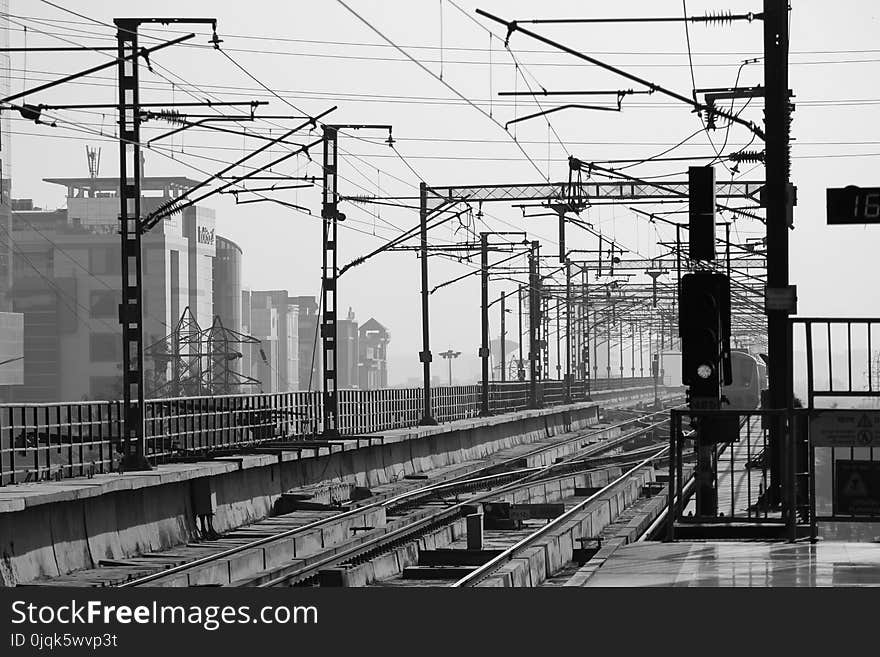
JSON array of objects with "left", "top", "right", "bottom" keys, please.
[{"left": 0, "top": 587, "right": 875, "bottom": 657}]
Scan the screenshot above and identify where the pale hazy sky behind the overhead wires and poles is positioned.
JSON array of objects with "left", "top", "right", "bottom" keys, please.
[{"left": 10, "top": 0, "right": 880, "bottom": 382}]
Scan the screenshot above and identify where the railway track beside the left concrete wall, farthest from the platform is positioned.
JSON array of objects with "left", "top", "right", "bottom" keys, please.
[{"left": 29, "top": 398, "right": 680, "bottom": 587}]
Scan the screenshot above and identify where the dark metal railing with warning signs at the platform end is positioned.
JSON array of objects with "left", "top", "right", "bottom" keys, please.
[{"left": 668, "top": 317, "right": 880, "bottom": 540}]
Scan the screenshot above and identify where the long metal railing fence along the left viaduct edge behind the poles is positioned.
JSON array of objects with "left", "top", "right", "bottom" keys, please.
[{"left": 0, "top": 377, "right": 652, "bottom": 486}]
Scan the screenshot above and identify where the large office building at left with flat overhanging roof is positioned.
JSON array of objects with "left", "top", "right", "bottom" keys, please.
[{"left": 12, "top": 177, "right": 215, "bottom": 401}]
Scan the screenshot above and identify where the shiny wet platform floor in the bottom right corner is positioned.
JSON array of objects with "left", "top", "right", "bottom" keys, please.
[{"left": 583, "top": 541, "right": 880, "bottom": 587}]
